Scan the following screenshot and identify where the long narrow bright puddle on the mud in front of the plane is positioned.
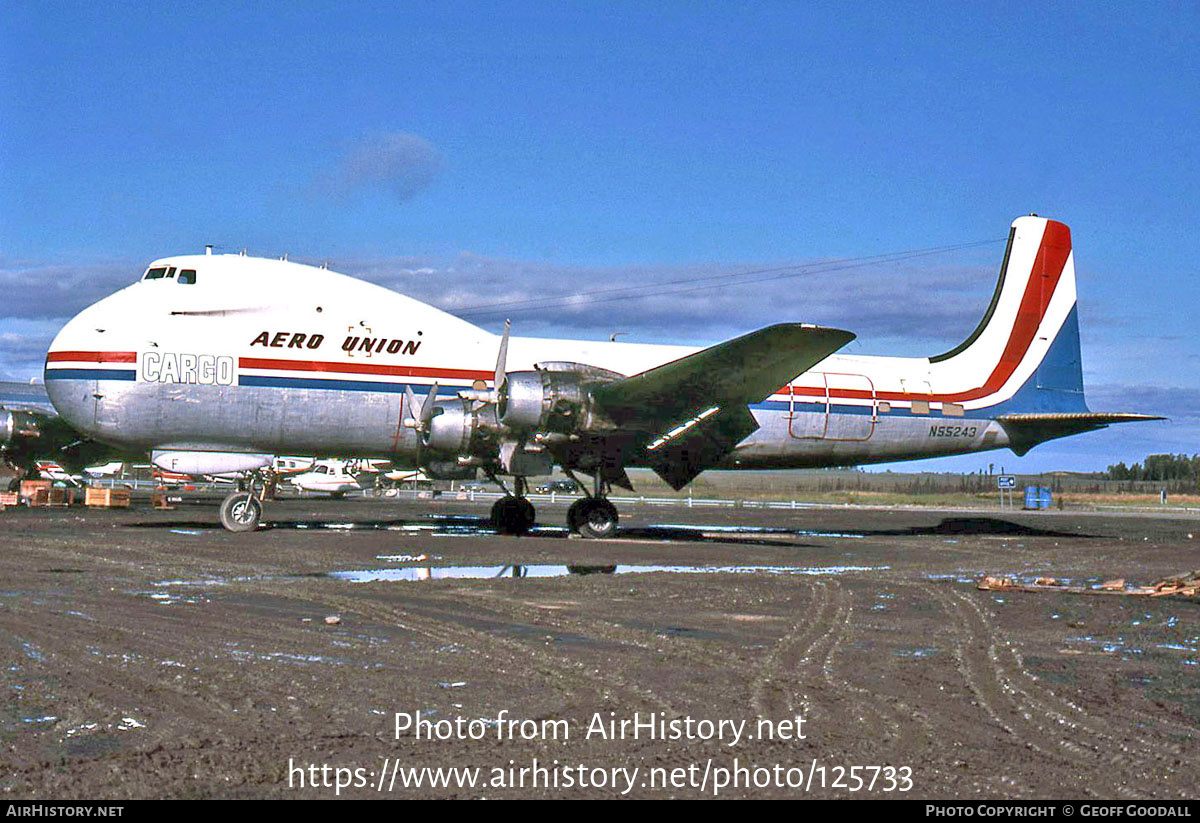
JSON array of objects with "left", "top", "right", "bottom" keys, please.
[{"left": 329, "top": 564, "right": 890, "bottom": 583}]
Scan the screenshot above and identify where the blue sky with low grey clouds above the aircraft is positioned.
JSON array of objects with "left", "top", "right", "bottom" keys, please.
[{"left": 0, "top": 1, "right": 1200, "bottom": 470}]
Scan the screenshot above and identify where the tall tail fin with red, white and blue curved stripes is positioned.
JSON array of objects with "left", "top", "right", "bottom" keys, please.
[{"left": 930, "top": 216, "right": 1087, "bottom": 413}]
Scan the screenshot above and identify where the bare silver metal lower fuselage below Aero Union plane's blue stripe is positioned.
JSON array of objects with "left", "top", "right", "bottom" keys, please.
[{"left": 48, "top": 379, "right": 1008, "bottom": 469}]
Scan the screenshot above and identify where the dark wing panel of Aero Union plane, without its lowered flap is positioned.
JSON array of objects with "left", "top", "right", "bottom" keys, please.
[{"left": 595, "top": 323, "right": 854, "bottom": 431}]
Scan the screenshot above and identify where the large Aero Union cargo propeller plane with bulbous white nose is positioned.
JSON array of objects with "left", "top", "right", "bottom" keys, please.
[{"left": 35, "top": 216, "right": 1152, "bottom": 537}]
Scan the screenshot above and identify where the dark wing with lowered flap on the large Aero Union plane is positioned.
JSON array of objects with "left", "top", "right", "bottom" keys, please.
[{"left": 594, "top": 323, "right": 854, "bottom": 489}]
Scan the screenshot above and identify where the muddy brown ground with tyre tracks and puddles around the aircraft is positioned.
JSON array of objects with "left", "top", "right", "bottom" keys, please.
[{"left": 0, "top": 500, "right": 1200, "bottom": 799}]
